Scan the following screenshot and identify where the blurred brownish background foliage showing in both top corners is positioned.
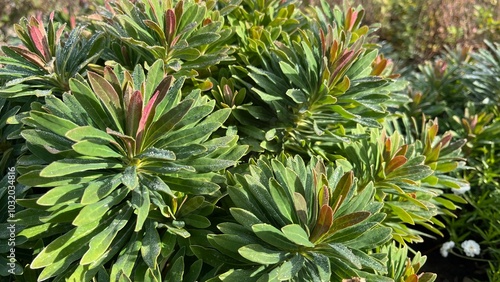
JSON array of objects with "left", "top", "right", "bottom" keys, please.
[{"left": 0, "top": 0, "right": 500, "bottom": 65}]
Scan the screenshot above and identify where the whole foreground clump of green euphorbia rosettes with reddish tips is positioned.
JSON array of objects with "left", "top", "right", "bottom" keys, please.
[{"left": 0, "top": 0, "right": 474, "bottom": 281}]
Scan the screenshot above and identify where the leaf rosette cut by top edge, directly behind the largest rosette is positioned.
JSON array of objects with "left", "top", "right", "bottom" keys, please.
[{"left": 93, "top": 0, "right": 234, "bottom": 77}]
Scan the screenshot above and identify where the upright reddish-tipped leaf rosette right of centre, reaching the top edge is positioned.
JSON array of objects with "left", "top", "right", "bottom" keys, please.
[{"left": 232, "top": 3, "right": 406, "bottom": 159}]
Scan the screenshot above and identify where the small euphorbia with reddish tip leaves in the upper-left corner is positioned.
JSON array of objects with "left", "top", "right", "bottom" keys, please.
[{"left": 0, "top": 13, "right": 103, "bottom": 98}]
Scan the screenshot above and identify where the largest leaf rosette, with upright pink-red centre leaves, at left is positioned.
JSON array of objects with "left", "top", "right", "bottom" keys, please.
[{"left": 14, "top": 60, "right": 247, "bottom": 281}]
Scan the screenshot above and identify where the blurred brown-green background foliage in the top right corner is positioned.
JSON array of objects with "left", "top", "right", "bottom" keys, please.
[{"left": 305, "top": 0, "right": 500, "bottom": 65}]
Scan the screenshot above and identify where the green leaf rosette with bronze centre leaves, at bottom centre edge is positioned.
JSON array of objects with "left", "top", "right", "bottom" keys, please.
[{"left": 197, "top": 156, "right": 391, "bottom": 281}]
